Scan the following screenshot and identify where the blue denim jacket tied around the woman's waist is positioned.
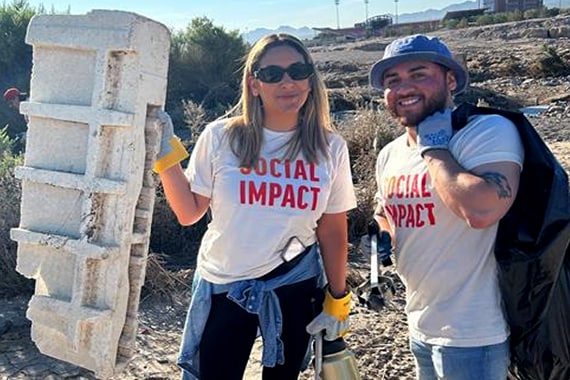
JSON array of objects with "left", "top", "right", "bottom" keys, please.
[{"left": 177, "top": 244, "right": 322, "bottom": 379}]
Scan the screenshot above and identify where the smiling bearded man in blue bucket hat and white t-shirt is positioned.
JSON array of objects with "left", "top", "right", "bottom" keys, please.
[{"left": 363, "top": 35, "right": 524, "bottom": 380}]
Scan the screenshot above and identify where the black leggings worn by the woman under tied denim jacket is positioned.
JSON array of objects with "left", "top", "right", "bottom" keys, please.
[{"left": 200, "top": 277, "right": 317, "bottom": 380}]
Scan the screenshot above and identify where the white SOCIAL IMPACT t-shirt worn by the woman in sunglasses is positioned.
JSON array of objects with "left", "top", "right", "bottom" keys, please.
[{"left": 186, "top": 120, "right": 356, "bottom": 284}]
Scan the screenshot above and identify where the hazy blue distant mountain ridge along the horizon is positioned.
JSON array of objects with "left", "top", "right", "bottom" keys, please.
[{"left": 242, "top": 0, "right": 570, "bottom": 43}]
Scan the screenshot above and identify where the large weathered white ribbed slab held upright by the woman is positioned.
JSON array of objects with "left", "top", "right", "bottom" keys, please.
[{"left": 11, "top": 10, "right": 170, "bottom": 377}]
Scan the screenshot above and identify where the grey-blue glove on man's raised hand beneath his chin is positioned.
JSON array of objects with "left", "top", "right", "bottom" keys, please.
[{"left": 417, "top": 108, "right": 453, "bottom": 157}]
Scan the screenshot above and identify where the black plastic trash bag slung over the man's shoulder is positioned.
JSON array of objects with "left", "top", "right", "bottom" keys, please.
[{"left": 453, "top": 104, "right": 570, "bottom": 380}]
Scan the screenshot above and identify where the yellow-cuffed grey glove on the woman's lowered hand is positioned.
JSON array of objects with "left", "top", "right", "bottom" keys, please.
[{"left": 307, "top": 289, "right": 352, "bottom": 341}]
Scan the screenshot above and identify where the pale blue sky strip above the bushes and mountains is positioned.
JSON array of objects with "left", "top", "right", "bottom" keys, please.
[{"left": 28, "top": 0, "right": 464, "bottom": 32}]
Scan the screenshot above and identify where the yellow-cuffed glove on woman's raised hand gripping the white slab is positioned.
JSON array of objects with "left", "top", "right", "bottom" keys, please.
[{"left": 153, "top": 111, "right": 189, "bottom": 173}]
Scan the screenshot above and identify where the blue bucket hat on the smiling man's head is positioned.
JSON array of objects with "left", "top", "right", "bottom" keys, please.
[{"left": 369, "top": 34, "right": 469, "bottom": 95}]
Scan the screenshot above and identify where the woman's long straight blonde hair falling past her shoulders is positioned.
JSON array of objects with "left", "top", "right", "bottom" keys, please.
[{"left": 222, "top": 34, "right": 334, "bottom": 167}]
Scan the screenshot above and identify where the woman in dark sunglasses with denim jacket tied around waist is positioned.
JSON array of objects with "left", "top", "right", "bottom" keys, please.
[{"left": 155, "top": 34, "right": 356, "bottom": 380}]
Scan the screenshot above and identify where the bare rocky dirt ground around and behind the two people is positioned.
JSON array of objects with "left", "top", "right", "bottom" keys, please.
[{"left": 0, "top": 17, "right": 570, "bottom": 380}]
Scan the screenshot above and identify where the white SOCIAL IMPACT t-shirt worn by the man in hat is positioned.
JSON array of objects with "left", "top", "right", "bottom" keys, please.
[{"left": 376, "top": 115, "right": 524, "bottom": 347}]
